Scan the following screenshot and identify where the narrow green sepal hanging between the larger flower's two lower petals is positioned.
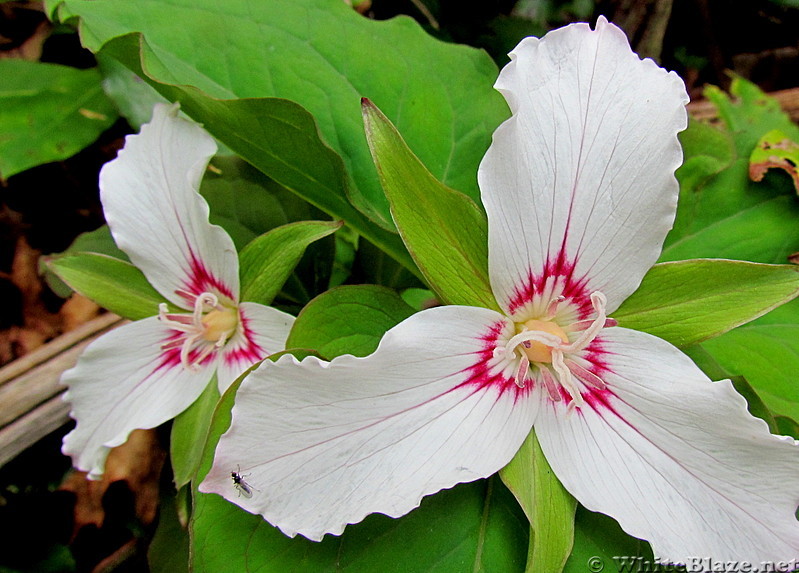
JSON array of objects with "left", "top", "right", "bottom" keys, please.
[{"left": 499, "top": 431, "right": 577, "bottom": 573}]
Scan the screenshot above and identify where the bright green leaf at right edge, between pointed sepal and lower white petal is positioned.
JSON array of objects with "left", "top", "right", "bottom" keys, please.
[{"left": 702, "top": 300, "right": 799, "bottom": 419}]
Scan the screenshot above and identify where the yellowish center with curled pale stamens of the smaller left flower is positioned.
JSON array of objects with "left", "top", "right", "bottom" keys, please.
[{"left": 158, "top": 292, "right": 239, "bottom": 372}]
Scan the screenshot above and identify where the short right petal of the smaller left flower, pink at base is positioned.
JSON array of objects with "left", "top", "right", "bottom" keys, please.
[{"left": 217, "top": 302, "right": 294, "bottom": 392}]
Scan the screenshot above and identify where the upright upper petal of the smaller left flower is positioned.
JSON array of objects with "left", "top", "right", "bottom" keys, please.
[{"left": 100, "top": 104, "right": 239, "bottom": 313}]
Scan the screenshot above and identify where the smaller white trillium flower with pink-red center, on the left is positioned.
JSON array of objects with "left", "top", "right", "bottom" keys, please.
[{"left": 62, "top": 104, "right": 294, "bottom": 477}]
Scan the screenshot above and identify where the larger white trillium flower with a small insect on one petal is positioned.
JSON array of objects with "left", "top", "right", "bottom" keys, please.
[{"left": 200, "top": 18, "right": 799, "bottom": 562}]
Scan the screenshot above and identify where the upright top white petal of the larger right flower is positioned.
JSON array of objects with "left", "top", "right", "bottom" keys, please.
[{"left": 478, "top": 18, "right": 688, "bottom": 315}]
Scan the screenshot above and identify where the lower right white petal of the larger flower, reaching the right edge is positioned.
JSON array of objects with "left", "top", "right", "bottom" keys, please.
[{"left": 536, "top": 328, "right": 799, "bottom": 564}]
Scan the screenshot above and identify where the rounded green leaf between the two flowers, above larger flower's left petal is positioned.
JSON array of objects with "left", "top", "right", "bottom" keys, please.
[{"left": 286, "top": 285, "right": 414, "bottom": 360}]
